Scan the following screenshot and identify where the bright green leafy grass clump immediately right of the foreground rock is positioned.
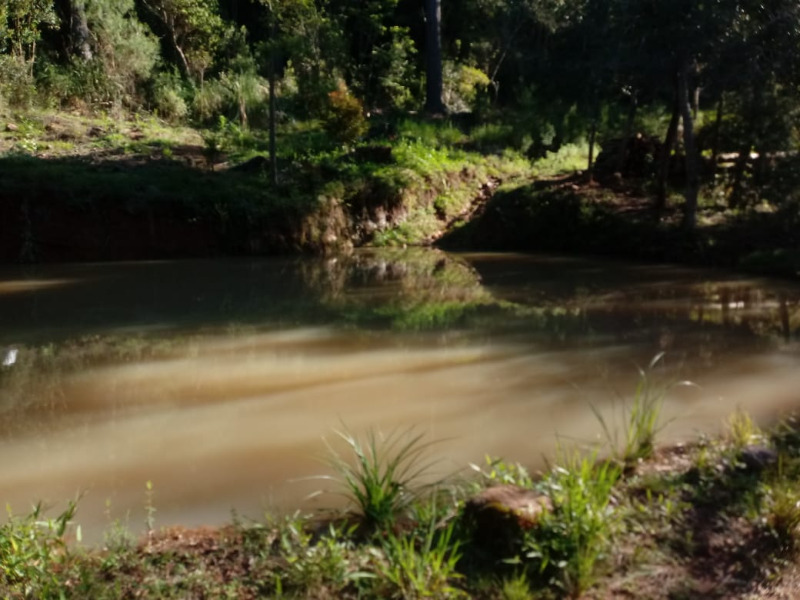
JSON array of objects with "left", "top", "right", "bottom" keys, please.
[{"left": 523, "top": 450, "right": 621, "bottom": 598}]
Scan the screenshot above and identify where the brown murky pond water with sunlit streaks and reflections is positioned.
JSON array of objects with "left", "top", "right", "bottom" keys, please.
[{"left": 0, "top": 250, "right": 800, "bottom": 540}]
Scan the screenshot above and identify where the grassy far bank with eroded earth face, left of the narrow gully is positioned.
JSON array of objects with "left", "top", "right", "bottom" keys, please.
[{"left": 0, "top": 113, "right": 530, "bottom": 261}]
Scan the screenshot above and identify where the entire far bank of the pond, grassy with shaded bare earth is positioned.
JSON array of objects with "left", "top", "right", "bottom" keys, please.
[{"left": 0, "top": 107, "right": 800, "bottom": 277}]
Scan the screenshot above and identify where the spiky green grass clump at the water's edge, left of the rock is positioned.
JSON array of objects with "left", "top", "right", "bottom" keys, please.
[{"left": 328, "top": 430, "right": 438, "bottom": 531}]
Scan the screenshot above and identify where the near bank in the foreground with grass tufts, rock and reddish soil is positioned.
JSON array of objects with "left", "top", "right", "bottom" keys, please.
[{"left": 0, "top": 380, "right": 800, "bottom": 599}]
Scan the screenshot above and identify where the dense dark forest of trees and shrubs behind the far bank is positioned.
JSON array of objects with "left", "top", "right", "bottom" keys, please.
[{"left": 0, "top": 0, "right": 800, "bottom": 268}]
